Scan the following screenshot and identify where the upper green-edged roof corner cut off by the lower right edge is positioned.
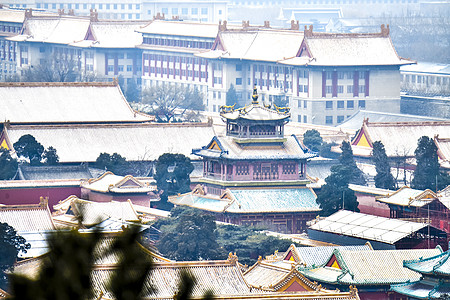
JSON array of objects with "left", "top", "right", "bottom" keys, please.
[{"left": 403, "top": 251, "right": 450, "bottom": 276}]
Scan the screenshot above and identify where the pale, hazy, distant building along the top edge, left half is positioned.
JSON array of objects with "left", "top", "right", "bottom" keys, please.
[{"left": 5, "top": 0, "right": 227, "bottom": 23}]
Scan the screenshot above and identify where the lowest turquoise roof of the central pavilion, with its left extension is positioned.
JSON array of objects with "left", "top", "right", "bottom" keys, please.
[{"left": 170, "top": 188, "right": 320, "bottom": 213}]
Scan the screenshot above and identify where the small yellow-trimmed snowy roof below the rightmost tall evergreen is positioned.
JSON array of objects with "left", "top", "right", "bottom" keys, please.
[{"left": 377, "top": 186, "right": 438, "bottom": 207}]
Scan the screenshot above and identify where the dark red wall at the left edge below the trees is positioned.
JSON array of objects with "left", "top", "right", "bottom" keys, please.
[{"left": 0, "top": 186, "right": 81, "bottom": 211}]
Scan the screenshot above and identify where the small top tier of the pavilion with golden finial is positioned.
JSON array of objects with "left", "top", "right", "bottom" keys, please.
[{"left": 220, "top": 86, "right": 291, "bottom": 139}]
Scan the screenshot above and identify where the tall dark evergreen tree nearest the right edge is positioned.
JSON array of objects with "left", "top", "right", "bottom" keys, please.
[{"left": 411, "top": 136, "right": 441, "bottom": 191}]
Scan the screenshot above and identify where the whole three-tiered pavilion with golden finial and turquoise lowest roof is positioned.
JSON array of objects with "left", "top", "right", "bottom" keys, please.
[{"left": 170, "top": 88, "right": 320, "bottom": 233}]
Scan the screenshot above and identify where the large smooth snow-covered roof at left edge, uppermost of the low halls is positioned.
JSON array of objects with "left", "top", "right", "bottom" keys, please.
[{"left": 0, "top": 82, "right": 154, "bottom": 123}]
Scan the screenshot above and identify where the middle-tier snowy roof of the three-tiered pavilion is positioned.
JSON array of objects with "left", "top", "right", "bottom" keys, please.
[{"left": 193, "top": 135, "right": 316, "bottom": 160}]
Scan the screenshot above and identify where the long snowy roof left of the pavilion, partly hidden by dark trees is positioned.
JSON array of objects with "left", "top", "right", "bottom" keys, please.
[{"left": 5, "top": 123, "right": 214, "bottom": 162}]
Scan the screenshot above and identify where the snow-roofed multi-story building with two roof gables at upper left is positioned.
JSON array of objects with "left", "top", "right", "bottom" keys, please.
[{"left": 8, "top": 10, "right": 147, "bottom": 83}]
